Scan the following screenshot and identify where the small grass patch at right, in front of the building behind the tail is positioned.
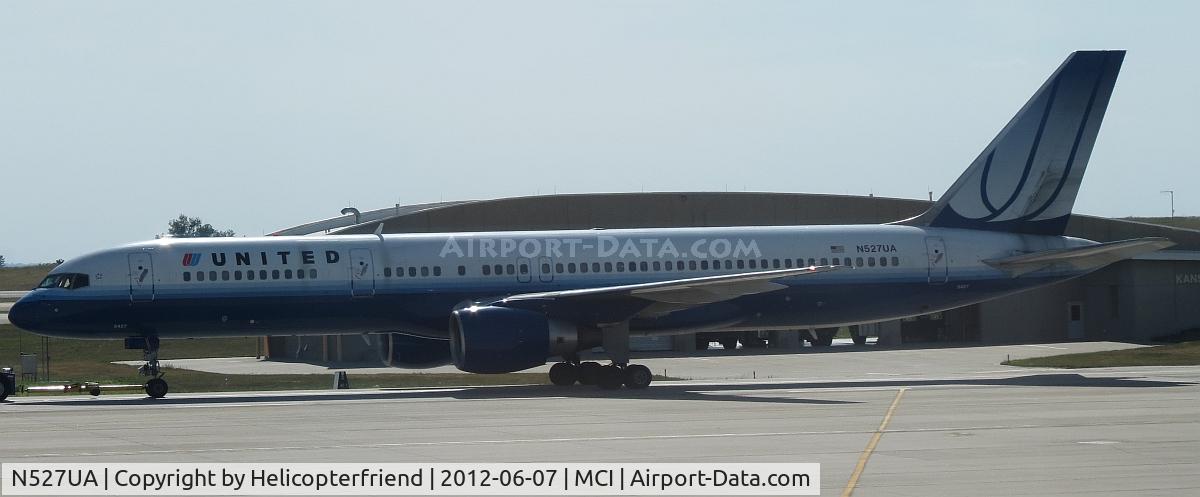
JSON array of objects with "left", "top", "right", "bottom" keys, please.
[{"left": 1001, "top": 341, "right": 1200, "bottom": 367}]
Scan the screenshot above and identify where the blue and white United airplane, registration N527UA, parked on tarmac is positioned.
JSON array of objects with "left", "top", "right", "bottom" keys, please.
[{"left": 8, "top": 52, "right": 1172, "bottom": 397}]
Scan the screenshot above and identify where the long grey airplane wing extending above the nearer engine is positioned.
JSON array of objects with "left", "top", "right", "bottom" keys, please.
[{"left": 493, "top": 265, "right": 841, "bottom": 322}]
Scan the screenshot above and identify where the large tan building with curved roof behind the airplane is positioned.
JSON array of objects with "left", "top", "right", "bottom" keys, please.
[{"left": 265, "top": 192, "right": 1200, "bottom": 363}]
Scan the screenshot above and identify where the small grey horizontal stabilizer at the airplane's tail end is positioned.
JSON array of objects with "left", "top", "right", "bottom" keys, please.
[{"left": 984, "top": 238, "right": 1175, "bottom": 276}]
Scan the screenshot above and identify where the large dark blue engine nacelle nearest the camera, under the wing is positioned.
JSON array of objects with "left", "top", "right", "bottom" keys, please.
[{"left": 450, "top": 306, "right": 600, "bottom": 373}]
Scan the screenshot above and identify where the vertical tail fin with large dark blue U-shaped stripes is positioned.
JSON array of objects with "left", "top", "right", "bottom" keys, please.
[{"left": 906, "top": 50, "right": 1124, "bottom": 235}]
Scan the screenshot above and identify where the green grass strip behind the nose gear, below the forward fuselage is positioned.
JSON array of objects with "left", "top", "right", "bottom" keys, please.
[{"left": 0, "top": 324, "right": 550, "bottom": 395}]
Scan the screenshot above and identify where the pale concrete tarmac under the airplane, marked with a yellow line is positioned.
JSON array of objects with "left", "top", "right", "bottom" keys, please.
[{"left": 0, "top": 343, "right": 1200, "bottom": 496}]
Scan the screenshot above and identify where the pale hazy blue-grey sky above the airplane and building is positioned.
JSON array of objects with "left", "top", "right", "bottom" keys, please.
[{"left": 0, "top": 0, "right": 1200, "bottom": 263}]
